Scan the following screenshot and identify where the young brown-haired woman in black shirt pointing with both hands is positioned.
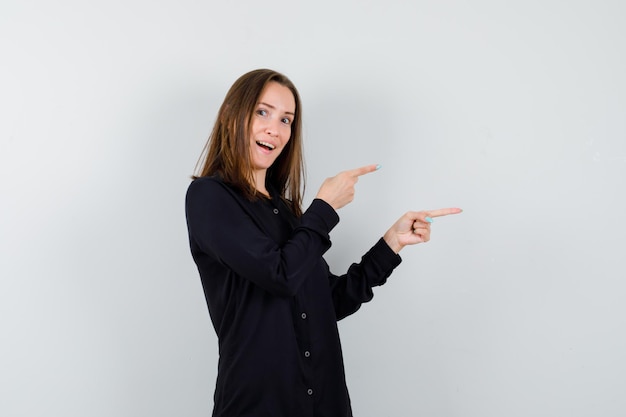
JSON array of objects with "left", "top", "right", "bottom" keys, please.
[{"left": 186, "top": 69, "right": 461, "bottom": 417}]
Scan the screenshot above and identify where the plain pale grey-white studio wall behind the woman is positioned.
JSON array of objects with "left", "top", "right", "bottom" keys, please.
[{"left": 0, "top": 0, "right": 626, "bottom": 417}]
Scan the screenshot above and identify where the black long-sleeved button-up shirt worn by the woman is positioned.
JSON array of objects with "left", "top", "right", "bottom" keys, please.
[{"left": 186, "top": 177, "right": 400, "bottom": 417}]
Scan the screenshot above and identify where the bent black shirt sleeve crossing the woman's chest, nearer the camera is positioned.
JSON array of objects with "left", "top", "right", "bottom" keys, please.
[{"left": 186, "top": 178, "right": 339, "bottom": 296}]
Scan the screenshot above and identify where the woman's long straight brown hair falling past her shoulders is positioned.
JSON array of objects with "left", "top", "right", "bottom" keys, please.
[{"left": 192, "top": 69, "right": 304, "bottom": 217}]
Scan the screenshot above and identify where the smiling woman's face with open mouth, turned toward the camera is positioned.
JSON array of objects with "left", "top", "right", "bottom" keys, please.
[{"left": 250, "top": 82, "right": 296, "bottom": 171}]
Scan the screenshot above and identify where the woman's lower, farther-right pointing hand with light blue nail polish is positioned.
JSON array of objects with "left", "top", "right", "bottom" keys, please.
[{"left": 383, "top": 208, "right": 463, "bottom": 253}]
